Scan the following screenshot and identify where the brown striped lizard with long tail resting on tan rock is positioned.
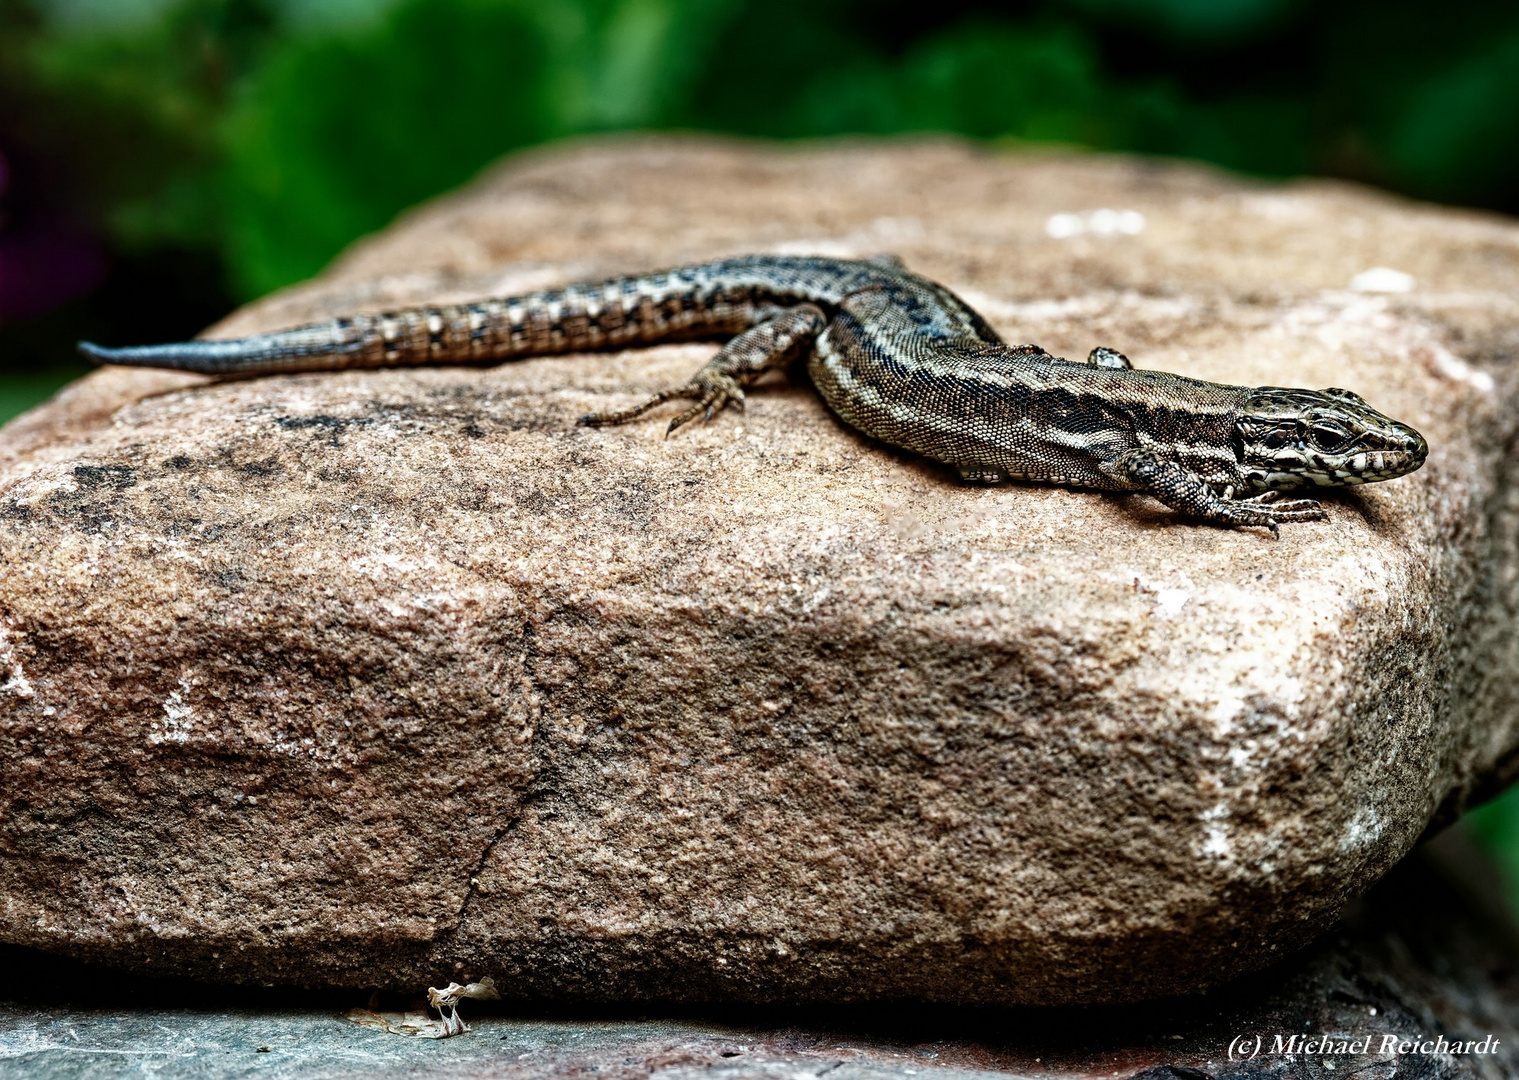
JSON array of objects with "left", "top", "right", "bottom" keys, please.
[{"left": 79, "top": 255, "right": 1428, "bottom": 535}]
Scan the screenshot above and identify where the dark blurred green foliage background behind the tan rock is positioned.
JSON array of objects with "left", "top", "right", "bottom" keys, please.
[{"left": 0, "top": 0, "right": 1519, "bottom": 896}]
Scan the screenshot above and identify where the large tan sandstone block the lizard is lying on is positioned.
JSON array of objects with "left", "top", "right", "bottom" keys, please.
[{"left": 0, "top": 140, "right": 1519, "bottom": 1004}]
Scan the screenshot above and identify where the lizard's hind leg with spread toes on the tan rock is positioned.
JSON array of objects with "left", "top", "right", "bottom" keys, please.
[{"left": 579, "top": 304, "right": 828, "bottom": 436}]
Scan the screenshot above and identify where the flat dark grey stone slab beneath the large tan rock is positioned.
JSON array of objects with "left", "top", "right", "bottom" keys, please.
[{"left": 0, "top": 834, "right": 1519, "bottom": 1080}]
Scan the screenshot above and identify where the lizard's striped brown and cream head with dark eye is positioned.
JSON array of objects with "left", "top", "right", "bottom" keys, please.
[{"left": 1235, "top": 386, "right": 1429, "bottom": 491}]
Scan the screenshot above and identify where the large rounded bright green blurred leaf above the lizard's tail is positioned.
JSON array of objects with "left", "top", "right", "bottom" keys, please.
[{"left": 226, "top": 0, "right": 551, "bottom": 296}]
